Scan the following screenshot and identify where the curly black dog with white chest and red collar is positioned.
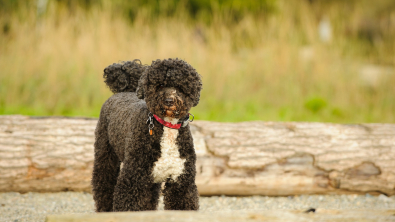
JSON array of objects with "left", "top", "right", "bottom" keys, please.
[{"left": 92, "top": 59, "right": 202, "bottom": 212}]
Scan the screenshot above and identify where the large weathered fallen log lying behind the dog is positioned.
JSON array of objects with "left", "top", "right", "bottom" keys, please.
[{"left": 0, "top": 116, "right": 395, "bottom": 195}]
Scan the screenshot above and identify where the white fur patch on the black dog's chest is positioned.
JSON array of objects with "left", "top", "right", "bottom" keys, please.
[{"left": 152, "top": 118, "right": 185, "bottom": 183}]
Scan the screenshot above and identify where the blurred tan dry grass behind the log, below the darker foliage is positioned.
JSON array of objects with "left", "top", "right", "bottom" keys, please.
[{"left": 0, "top": 1, "right": 395, "bottom": 123}]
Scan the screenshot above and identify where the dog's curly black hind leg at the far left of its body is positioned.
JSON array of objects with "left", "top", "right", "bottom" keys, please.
[{"left": 92, "top": 113, "right": 120, "bottom": 212}]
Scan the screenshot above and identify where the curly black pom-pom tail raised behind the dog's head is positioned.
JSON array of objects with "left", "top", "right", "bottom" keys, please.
[{"left": 103, "top": 59, "right": 147, "bottom": 93}]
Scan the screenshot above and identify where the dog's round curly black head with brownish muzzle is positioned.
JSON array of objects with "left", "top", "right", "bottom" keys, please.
[{"left": 136, "top": 59, "right": 202, "bottom": 119}]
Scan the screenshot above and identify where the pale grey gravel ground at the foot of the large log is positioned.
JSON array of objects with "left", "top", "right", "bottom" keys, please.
[{"left": 0, "top": 192, "right": 395, "bottom": 222}]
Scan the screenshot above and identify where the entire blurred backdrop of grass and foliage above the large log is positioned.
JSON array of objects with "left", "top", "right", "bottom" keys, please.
[{"left": 0, "top": 0, "right": 395, "bottom": 122}]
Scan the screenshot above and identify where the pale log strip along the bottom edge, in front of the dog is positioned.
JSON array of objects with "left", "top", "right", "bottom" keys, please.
[{"left": 45, "top": 210, "right": 395, "bottom": 222}]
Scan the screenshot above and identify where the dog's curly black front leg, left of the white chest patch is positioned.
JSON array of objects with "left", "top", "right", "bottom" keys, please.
[{"left": 113, "top": 138, "right": 161, "bottom": 211}]
